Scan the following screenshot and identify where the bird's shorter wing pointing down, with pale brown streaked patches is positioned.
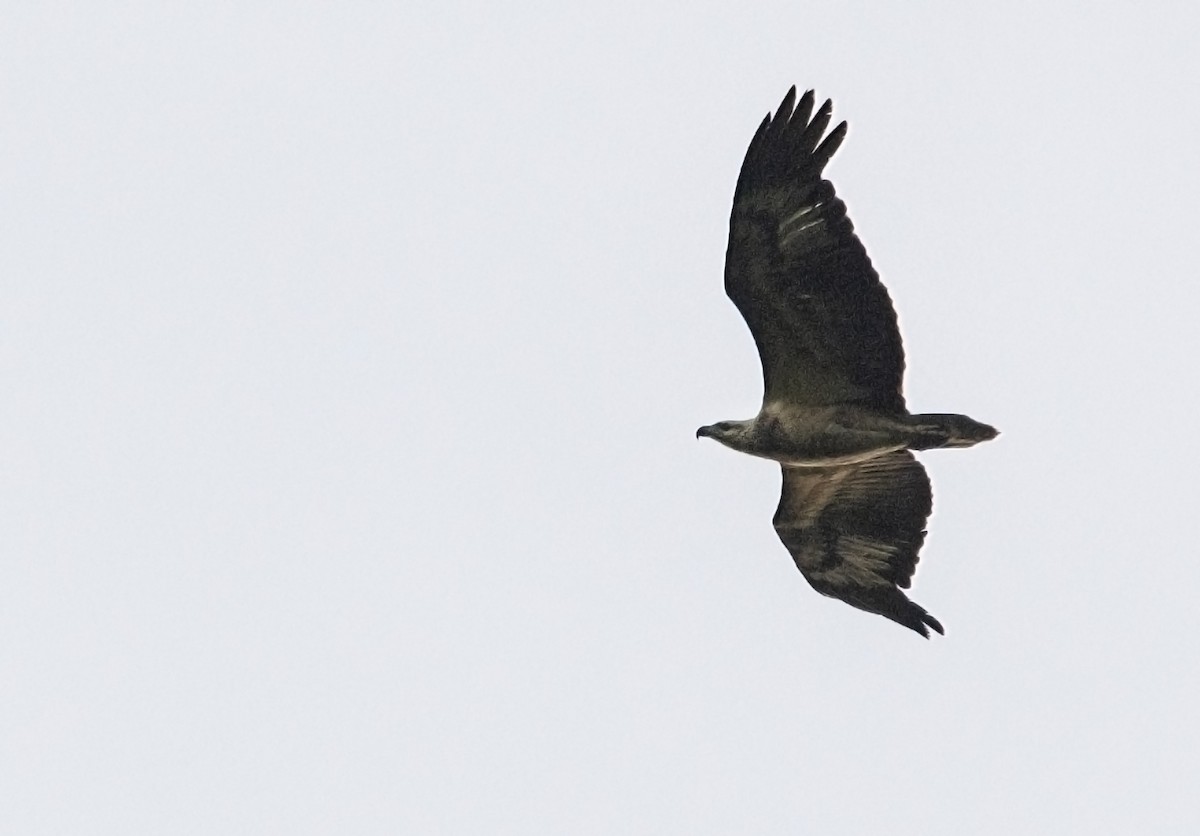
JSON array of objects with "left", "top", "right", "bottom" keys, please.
[{"left": 775, "top": 450, "right": 944, "bottom": 638}]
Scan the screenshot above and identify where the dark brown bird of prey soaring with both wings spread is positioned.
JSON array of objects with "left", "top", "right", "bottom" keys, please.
[{"left": 696, "top": 86, "right": 997, "bottom": 638}]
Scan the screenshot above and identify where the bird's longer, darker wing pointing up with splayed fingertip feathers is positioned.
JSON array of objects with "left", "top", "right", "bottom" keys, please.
[{"left": 725, "top": 88, "right": 905, "bottom": 413}]
